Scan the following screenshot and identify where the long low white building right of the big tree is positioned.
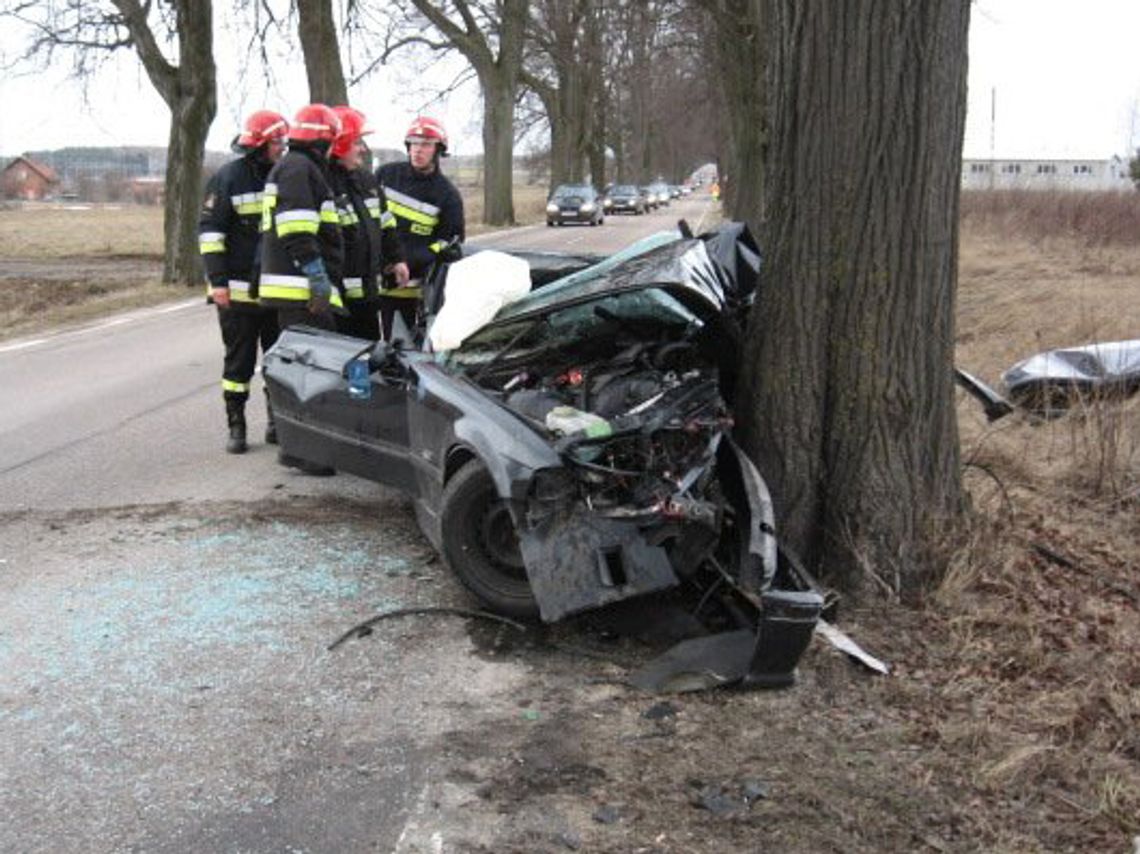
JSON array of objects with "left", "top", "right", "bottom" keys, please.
[{"left": 962, "top": 157, "right": 1133, "bottom": 190}]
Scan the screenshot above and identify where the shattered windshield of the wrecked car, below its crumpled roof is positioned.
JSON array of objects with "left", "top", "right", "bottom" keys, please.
[{"left": 449, "top": 287, "right": 702, "bottom": 366}]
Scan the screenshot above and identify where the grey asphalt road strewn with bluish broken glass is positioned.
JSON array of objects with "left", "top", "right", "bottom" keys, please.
[{"left": 0, "top": 198, "right": 710, "bottom": 852}]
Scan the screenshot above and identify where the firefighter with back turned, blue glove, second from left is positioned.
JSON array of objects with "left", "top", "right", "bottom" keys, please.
[{"left": 258, "top": 104, "right": 344, "bottom": 330}]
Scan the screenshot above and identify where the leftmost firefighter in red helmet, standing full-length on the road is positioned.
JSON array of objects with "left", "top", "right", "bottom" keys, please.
[{"left": 198, "top": 109, "right": 288, "bottom": 454}]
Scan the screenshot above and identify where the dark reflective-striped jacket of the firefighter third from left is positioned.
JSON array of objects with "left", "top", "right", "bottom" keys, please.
[{"left": 329, "top": 162, "right": 404, "bottom": 302}]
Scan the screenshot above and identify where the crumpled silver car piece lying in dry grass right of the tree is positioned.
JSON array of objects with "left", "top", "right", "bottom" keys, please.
[{"left": 1002, "top": 341, "right": 1140, "bottom": 414}]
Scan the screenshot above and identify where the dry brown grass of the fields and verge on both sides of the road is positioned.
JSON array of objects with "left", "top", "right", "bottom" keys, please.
[{"left": 0, "top": 189, "right": 1140, "bottom": 852}]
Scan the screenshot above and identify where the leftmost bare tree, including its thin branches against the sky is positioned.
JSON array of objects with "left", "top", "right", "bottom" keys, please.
[{"left": 0, "top": 0, "right": 218, "bottom": 285}]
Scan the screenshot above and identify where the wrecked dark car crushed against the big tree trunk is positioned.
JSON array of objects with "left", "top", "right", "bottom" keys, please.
[{"left": 264, "top": 223, "right": 823, "bottom": 689}]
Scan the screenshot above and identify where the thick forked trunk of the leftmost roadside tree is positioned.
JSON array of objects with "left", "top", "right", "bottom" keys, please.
[{"left": 114, "top": 0, "right": 218, "bottom": 286}]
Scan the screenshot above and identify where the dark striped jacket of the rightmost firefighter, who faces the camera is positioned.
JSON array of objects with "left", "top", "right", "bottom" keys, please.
[{"left": 376, "top": 161, "right": 466, "bottom": 296}]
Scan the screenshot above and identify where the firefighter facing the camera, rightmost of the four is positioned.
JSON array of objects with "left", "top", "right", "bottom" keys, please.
[{"left": 376, "top": 116, "right": 466, "bottom": 339}]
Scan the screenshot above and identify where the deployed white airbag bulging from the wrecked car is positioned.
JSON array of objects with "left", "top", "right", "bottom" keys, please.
[{"left": 428, "top": 250, "right": 530, "bottom": 352}]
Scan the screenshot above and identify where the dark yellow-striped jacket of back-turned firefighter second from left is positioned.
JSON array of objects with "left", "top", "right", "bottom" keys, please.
[{"left": 258, "top": 143, "right": 344, "bottom": 309}]
